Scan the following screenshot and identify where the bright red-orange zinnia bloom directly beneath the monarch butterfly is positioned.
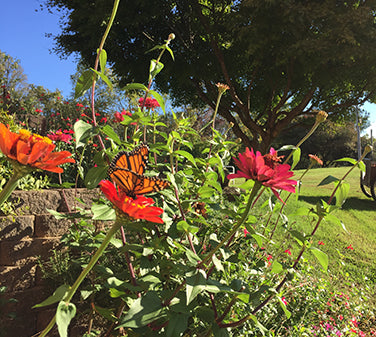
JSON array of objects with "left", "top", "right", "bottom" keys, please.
[{"left": 100, "top": 180, "right": 163, "bottom": 223}]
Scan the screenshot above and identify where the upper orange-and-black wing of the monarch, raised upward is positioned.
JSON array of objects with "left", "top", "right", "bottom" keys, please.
[{"left": 110, "top": 144, "right": 149, "bottom": 175}]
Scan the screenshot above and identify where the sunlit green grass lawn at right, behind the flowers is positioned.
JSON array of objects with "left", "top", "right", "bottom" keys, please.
[{"left": 289, "top": 167, "right": 376, "bottom": 283}]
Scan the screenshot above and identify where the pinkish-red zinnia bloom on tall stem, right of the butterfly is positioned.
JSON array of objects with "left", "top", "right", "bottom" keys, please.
[{"left": 227, "top": 148, "right": 297, "bottom": 202}]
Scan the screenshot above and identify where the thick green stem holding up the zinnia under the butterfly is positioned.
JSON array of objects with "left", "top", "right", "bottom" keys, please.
[{"left": 39, "top": 221, "right": 121, "bottom": 337}]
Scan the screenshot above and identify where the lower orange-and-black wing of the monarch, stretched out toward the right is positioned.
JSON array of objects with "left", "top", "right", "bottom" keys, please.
[{"left": 108, "top": 168, "right": 170, "bottom": 198}]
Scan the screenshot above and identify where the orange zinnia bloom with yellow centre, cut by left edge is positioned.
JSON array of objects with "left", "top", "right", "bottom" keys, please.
[{"left": 0, "top": 123, "right": 75, "bottom": 173}]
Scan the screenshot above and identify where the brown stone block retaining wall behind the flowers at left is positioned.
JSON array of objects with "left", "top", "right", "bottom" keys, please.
[{"left": 0, "top": 189, "right": 100, "bottom": 337}]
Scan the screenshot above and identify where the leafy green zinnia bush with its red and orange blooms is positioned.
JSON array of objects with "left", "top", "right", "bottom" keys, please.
[{"left": 0, "top": 1, "right": 374, "bottom": 337}]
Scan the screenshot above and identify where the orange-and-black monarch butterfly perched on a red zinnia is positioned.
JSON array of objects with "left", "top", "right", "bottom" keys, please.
[{"left": 108, "top": 144, "right": 170, "bottom": 198}]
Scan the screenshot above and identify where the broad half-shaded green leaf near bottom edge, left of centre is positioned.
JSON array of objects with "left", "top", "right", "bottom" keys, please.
[{"left": 118, "top": 291, "right": 166, "bottom": 328}]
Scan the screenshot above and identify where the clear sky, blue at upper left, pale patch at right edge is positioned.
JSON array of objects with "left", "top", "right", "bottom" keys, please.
[{"left": 0, "top": 0, "right": 376, "bottom": 136}]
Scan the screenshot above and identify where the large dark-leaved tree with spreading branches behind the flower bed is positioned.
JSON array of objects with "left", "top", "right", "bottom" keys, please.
[{"left": 46, "top": 0, "right": 376, "bottom": 150}]
